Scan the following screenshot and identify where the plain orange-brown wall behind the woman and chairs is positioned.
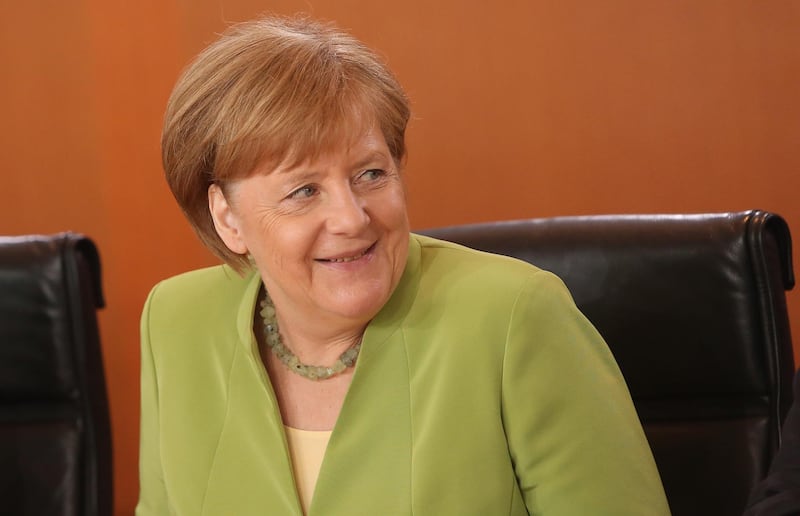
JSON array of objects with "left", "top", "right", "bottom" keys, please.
[{"left": 0, "top": 0, "right": 800, "bottom": 515}]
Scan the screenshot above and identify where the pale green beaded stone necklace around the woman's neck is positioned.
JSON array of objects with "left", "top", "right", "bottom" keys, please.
[{"left": 261, "top": 290, "right": 361, "bottom": 380}]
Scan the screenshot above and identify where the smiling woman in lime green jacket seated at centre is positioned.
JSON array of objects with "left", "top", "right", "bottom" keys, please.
[{"left": 137, "top": 14, "right": 668, "bottom": 516}]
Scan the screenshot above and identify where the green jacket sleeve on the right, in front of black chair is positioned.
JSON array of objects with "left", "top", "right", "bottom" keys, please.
[{"left": 502, "top": 271, "right": 669, "bottom": 516}]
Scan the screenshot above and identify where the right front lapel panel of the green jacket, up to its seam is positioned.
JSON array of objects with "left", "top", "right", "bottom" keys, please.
[{"left": 309, "top": 238, "right": 420, "bottom": 516}]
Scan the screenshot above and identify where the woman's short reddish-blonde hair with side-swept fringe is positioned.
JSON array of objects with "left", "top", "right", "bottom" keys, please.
[{"left": 161, "top": 17, "right": 410, "bottom": 272}]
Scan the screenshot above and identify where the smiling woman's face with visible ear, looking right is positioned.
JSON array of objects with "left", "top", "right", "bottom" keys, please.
[{"left": 209, "top": 123, "right": 409, "bottom": 332}]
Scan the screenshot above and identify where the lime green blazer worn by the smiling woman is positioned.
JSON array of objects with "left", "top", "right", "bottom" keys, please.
[{"left": 136, "top": 235, "right": 669, "bottom": 516}]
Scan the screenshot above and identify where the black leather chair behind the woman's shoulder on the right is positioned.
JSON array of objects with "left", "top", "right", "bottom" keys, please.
[{"left": 423, "top": 211, "right": 794, "bottom": 516}]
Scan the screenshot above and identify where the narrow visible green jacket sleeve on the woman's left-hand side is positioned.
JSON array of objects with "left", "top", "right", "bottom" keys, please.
[{"left": 136, "top": 287, "right": 170, "bottom": 516}]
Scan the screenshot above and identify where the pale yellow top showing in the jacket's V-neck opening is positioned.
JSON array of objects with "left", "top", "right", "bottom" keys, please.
[{"left": 284, "top": 425, "right": 331, "bottom": 514}]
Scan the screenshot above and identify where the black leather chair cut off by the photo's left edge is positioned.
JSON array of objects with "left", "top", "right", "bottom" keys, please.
[{"left": 0, "top": 233, "right": 112, "bottom": 516}]
